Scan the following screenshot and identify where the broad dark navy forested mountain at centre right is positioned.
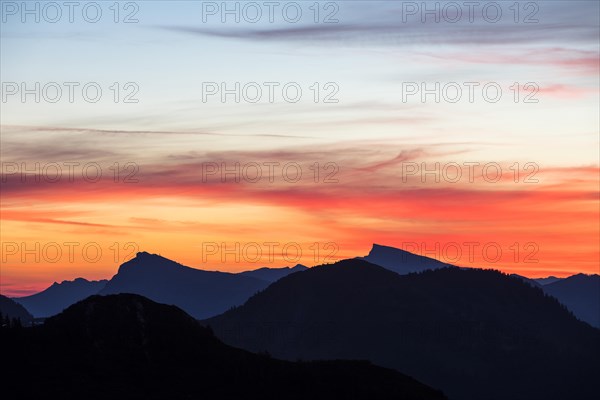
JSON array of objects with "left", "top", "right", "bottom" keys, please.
[{"left": 205, "top": 259, "right": 600, "bottom": 400}]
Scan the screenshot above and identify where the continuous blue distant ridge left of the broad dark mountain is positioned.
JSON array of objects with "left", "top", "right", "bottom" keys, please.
[{"left": 13, "top": 252, "right": 307, "bottom": 319}]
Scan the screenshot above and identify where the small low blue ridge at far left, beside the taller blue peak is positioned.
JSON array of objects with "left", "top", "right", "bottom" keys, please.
[{"left": 13, "top": 278, "right": 108, "bottom": 318}]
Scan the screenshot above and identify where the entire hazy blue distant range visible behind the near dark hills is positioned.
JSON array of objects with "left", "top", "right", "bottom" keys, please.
[{"left": 13, "top": 244, "right": 600, "bottom": 328}]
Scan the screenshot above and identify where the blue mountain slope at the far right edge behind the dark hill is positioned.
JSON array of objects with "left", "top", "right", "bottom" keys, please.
[{"left": 542, "top": 274, "right": 600, "bottom": 328}]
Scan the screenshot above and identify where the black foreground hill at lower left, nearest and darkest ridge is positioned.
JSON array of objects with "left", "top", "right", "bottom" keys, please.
[{"left": 0, "top": 295, "right": 445, "bottom": 400}]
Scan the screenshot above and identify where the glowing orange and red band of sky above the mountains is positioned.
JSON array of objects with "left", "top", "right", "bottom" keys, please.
[{"left": 1, "top": 145, "right": 600, "bottom": 295}]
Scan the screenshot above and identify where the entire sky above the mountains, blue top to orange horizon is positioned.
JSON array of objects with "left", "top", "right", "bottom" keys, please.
[{"left": 0, "top": 0, "right": 600, "bottom": 296}]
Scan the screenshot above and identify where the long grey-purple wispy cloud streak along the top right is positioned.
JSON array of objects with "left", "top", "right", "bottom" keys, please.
[{"left": 157, "top": 2, "right": 599, "bottom": 46}]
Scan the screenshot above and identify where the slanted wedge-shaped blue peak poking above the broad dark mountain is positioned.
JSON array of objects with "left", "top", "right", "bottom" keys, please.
[{"left": 362, "top": 244, "right": 454, "bottom": 275}]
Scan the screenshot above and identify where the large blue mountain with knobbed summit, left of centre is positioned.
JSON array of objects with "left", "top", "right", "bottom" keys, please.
[{"left": 99, "top": 252, "right": 269, "bottom": 319}]
